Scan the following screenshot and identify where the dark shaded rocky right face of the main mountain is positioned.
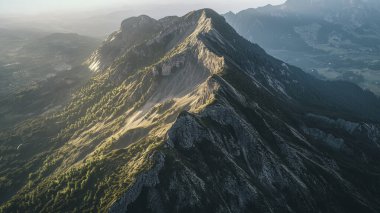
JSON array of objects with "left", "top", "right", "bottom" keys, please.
[{"left": 106, "top": 8, "right": 379, "bottom": 212}]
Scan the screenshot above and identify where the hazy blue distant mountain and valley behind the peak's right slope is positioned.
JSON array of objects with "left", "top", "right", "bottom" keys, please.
[{"left": 224, "top": 0, "right": 380, "bottom": 95}]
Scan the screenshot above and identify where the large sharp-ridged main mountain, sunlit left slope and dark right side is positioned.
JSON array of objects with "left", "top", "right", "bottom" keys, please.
[{"left": 0, "top": 9, "right": 380, "bottom": 212}]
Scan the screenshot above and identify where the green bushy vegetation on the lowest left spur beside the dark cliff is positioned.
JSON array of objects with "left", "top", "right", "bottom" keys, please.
[{"left": 2, "top": 136, "right": 160, "bottom": 212}]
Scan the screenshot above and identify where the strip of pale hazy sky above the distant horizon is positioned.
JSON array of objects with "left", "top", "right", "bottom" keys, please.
[{"left": 0, "top": 0, "right": 285, "bottom": 15}]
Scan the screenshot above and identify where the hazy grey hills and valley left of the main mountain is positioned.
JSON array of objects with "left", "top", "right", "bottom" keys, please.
[{"left": 0, "top": 30, "right": 101, "bottom": 129}]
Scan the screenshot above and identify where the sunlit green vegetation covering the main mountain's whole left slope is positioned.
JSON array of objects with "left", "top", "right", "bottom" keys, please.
[{"left": 0, "top": 20, "right": 206, "bottom": 212}]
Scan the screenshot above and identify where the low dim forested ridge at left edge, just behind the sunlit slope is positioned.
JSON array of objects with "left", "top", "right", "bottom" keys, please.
[{"left": 0, "top": 66, "right": 93, "bottom": 129}]
